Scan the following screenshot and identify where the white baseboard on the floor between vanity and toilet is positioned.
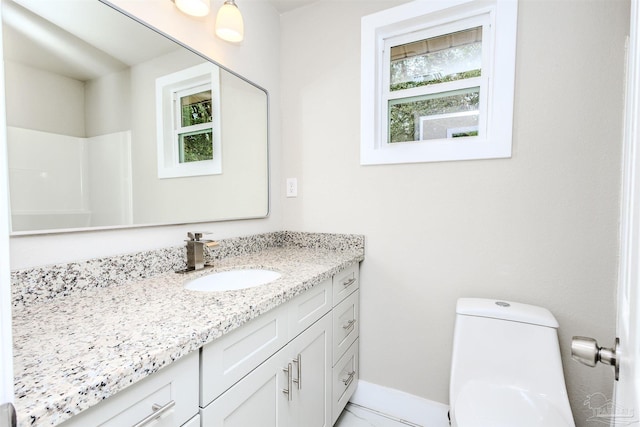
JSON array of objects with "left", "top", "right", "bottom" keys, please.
[{"left": 350, "top": 380, "right": 449, "bottom": 427}]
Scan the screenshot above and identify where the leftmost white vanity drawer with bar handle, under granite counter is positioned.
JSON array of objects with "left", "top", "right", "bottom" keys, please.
[{"left": 62, "top": 351, "right": 198, "bottom": 427}]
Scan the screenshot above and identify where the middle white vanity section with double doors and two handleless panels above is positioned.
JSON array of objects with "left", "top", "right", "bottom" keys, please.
[{"left": 201, "top": 279, "right": 332, "bottom": 427}]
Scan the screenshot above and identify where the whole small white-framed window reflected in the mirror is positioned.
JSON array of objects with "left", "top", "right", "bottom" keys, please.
[{"left": 156, "top": 63, "right": 222, "bottom": 178}]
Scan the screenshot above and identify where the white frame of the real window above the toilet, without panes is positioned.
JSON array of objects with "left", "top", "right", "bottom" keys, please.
[{"left": 360, "top": 0, "right": 517, "bottom": 165}]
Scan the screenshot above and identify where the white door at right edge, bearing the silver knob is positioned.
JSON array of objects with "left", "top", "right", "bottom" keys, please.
[{"left": 610, "top": 0, "right": 640, "bottom": 425}]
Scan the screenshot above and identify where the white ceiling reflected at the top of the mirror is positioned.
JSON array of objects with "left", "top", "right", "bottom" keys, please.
[{"left": 2, "top": 0, "right": 177, "bottom": 81}]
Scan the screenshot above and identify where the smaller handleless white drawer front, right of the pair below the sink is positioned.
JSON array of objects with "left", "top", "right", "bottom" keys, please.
[{"left": 288, "top": 279, "right": 332, "bottom": 339}]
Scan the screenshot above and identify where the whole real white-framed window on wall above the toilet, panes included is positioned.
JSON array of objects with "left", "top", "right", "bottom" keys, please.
[{"left": 361, "top": 0, "right": 517, "bottom": 164}]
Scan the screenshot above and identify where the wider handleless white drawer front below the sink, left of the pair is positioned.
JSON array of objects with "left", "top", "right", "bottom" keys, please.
[{"left": 200, "top": 304, "right": 288, "bottom": 408}]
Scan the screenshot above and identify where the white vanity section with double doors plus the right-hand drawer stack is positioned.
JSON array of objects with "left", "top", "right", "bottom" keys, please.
[{"left": 200, "top": 263, "right": 360, "bottom": 427}]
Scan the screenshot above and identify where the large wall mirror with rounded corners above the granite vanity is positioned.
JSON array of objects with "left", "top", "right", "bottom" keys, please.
[{"left": 2, "top": 0, "right": 269, "bottom": 234}]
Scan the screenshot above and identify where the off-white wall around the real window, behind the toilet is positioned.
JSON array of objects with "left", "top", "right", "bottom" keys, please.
[{"left": 281, "top": 0, "right": 629, "bottom": 426}]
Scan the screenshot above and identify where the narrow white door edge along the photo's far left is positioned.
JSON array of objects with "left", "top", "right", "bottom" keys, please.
[{"left": 0, "top": 0, "right": 14, "bottom": 427}]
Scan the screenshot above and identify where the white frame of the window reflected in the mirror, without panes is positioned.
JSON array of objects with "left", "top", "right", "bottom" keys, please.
[{"left": 156, "top": 63, "right": 222, "bottom": 179}]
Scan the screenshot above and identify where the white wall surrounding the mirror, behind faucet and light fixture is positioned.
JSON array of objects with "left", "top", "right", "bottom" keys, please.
[{"left": 10, "top": 0, "right": 283, "bottom": 269}]
